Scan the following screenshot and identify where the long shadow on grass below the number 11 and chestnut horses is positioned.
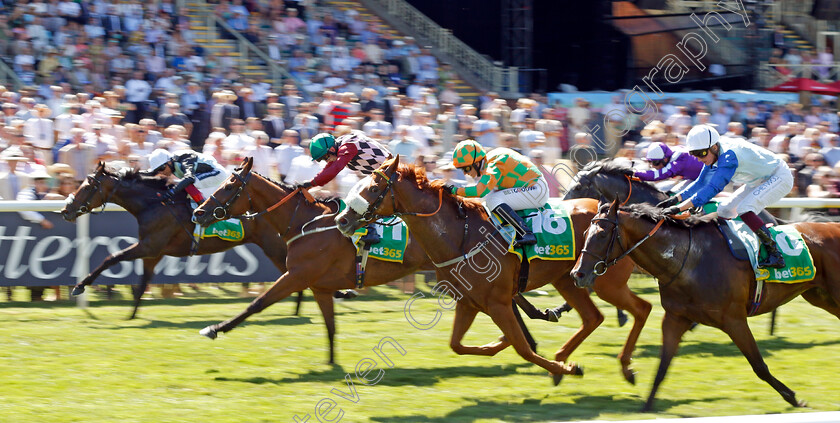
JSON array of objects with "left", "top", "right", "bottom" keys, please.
[{"left": 214, "top": 363, "right": 536, "bottom": 386}]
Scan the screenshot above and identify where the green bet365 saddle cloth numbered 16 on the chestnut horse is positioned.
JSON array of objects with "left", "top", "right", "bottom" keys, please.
[{"left": 487, "top": 198, "right": 575, "bottom": 261}]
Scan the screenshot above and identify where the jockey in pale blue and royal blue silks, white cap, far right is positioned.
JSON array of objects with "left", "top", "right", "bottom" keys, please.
[{"left": 657, "top": 125, "right": 793, "bottom": 268}]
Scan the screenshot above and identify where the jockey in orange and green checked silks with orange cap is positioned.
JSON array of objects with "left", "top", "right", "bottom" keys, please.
[{"left": 444, "top": 140, "right": 548, "bottom": 247}]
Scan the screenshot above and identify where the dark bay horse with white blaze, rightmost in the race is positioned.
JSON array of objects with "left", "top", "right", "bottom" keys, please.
[{"left": 572, "top": 201, "right": 840, "bottom": 411}]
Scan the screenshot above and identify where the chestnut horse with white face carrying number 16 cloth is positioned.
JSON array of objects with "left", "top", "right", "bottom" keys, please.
[{"left": 336, "top": 158, "right": 651, "bottom": 383}]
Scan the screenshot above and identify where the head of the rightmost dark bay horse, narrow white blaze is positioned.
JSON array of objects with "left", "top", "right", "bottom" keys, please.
[{"left": 571, "top": 200, "right": 621, "bottom": 288}]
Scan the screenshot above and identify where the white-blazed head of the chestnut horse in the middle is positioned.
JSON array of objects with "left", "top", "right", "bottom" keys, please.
[{"left": 335, "top": 156, "right": 401, "bottom": 236}]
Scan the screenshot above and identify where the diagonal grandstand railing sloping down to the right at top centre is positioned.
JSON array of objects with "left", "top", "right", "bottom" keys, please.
[{"left": 361, "top": 0, "right": 521, "bottom": 97}]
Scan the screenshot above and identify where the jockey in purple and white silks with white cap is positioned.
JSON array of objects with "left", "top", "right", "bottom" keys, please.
[{"left": 633, "top": 142, "right": 703, "bottom": 191}]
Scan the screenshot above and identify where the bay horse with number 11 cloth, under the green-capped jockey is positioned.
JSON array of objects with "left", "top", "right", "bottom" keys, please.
[{"left": 193, "top": 157, "right": 560, "bottom": 364}]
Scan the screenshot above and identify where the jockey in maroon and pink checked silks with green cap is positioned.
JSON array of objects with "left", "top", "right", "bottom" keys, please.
[{"left": 298, "top": 131, "right": 391, "bottom": 244}]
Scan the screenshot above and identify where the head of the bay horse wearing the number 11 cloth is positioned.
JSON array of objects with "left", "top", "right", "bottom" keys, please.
[{"left": 193, "top": 157, "right": 254, "bottom": 226}]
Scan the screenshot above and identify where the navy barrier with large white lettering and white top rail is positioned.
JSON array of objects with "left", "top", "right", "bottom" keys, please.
[{"left": 0, "top": 198, "right": 840, "bottom": 286}]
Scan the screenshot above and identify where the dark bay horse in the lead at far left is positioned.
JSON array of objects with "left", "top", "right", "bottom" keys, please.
[{"left": 61, "top": 163, "right": 286, "bottom": 319}]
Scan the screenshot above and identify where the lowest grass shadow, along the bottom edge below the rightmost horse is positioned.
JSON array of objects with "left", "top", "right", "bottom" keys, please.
[{"left": 371, "top": 396, "right": 709, "bottom": 423}]
